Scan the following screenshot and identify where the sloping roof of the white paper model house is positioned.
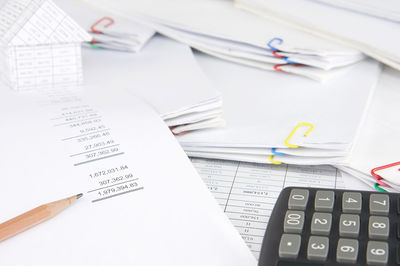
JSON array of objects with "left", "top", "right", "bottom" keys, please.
[{"left": 0, "top": 0, "right": 92, "bottom": 46}]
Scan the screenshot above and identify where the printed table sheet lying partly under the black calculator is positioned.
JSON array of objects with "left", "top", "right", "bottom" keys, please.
[{"left": 191, "top": 158, "right": 345, "bottom": 259}]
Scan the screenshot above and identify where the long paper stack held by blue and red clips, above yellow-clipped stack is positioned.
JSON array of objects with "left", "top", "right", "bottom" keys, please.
[{"left": 83, "top": 0, "right": 363, "bottom": 80}]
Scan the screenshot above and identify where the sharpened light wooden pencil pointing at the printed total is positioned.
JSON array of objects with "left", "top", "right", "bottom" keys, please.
[{"left": 0, "top": 193, "right": 83, "bottom": 242}]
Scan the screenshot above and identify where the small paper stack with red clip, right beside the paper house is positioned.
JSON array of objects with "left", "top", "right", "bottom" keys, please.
[{"left": 55, "top": 0, "right": 155, "bottom": 52}]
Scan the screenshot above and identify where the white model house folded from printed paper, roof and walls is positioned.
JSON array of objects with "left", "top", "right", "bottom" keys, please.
[{"left": 0, "top": 0, "right": 91, "bottom": 90}]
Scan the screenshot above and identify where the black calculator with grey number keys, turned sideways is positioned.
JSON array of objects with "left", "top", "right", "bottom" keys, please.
[{"left": 259, "top": 187, "right": 400, "bottom": 266}]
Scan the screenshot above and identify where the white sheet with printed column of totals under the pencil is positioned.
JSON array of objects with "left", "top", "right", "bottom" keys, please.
[{"left": 0, "top": 86, "right": 256, "bottom": 266}]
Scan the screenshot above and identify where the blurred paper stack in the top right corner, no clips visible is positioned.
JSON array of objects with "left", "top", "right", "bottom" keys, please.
[{"left": 235, "top": 0, "right": 400, "bottom": 70}]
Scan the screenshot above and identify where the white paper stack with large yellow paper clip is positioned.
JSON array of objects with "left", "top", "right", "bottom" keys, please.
[{"left": 178, "top": 51, "right": 380, "bottom": 164}]
